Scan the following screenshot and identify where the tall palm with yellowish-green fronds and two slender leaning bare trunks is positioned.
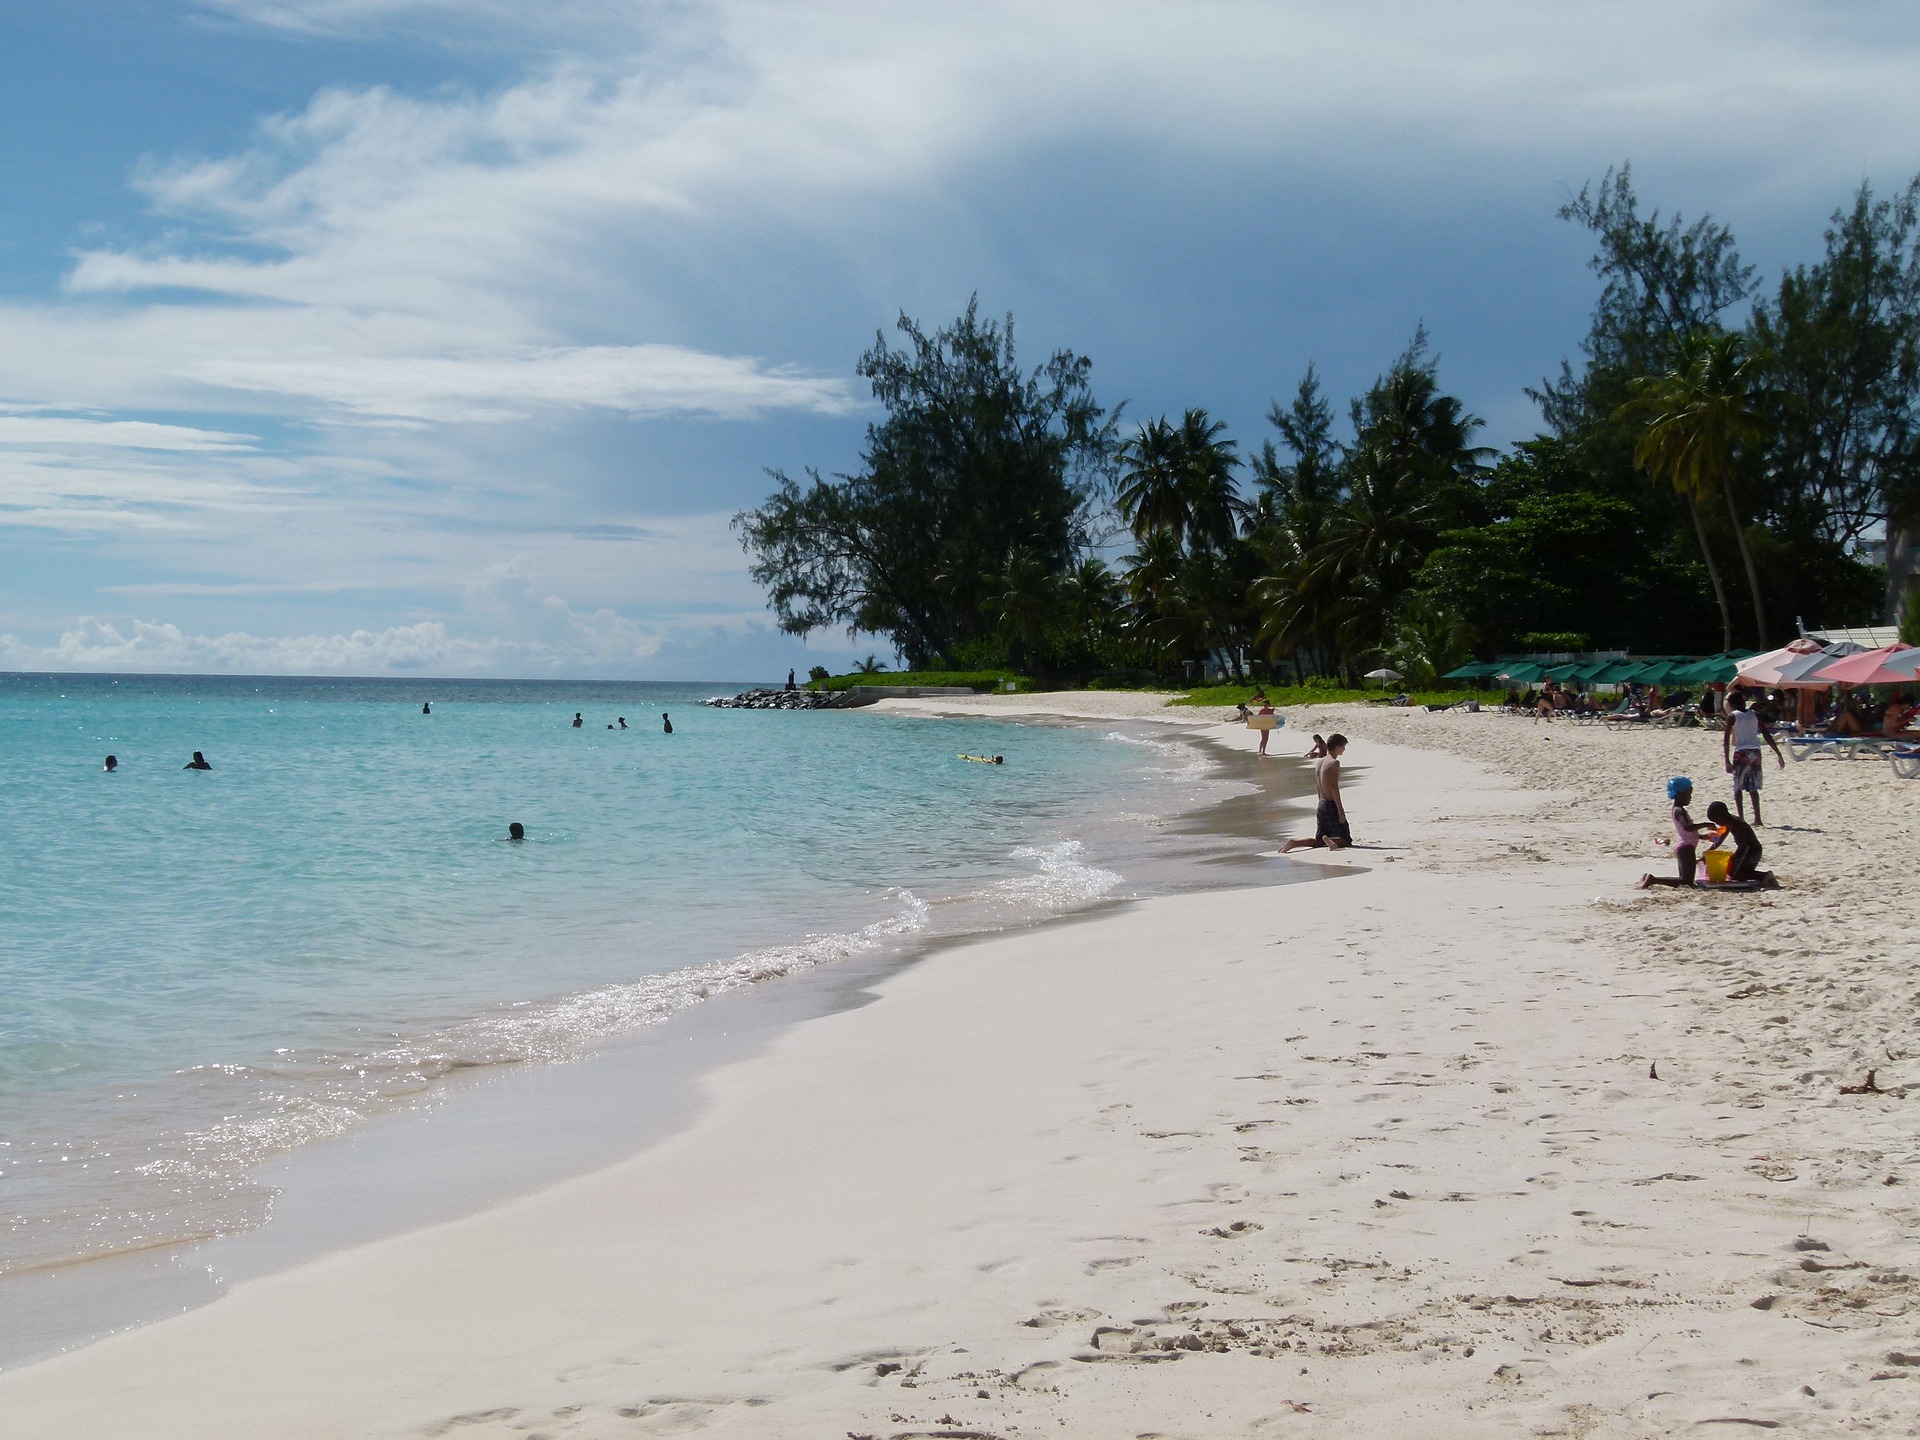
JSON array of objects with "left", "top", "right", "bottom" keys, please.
[{"left": 1615, "top": 330, "right": 1770, "bottom": 649}]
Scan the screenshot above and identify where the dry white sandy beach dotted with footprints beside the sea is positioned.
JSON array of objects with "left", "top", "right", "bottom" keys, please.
[{"left": 0, "top": 695, "right": 1920, "bottom": 1440}]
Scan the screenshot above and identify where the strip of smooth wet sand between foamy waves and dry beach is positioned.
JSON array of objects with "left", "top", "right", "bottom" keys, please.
[{"left": 0, "top": 716, "right": 1298, "bottom": 1373}]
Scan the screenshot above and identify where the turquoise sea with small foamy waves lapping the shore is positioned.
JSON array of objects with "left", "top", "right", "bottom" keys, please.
[{"left": 0, "top": 676, "right": 1196, "bottom": 1273}]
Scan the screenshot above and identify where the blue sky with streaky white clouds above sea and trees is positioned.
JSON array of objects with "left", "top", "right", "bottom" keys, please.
[{"left": 0, "top": 0, "right": 1920, "bottom": 680}]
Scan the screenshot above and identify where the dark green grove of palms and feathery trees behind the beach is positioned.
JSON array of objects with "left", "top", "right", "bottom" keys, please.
[{"left": 735, "top": 167, "right": 1920, "bottom": 695}]
